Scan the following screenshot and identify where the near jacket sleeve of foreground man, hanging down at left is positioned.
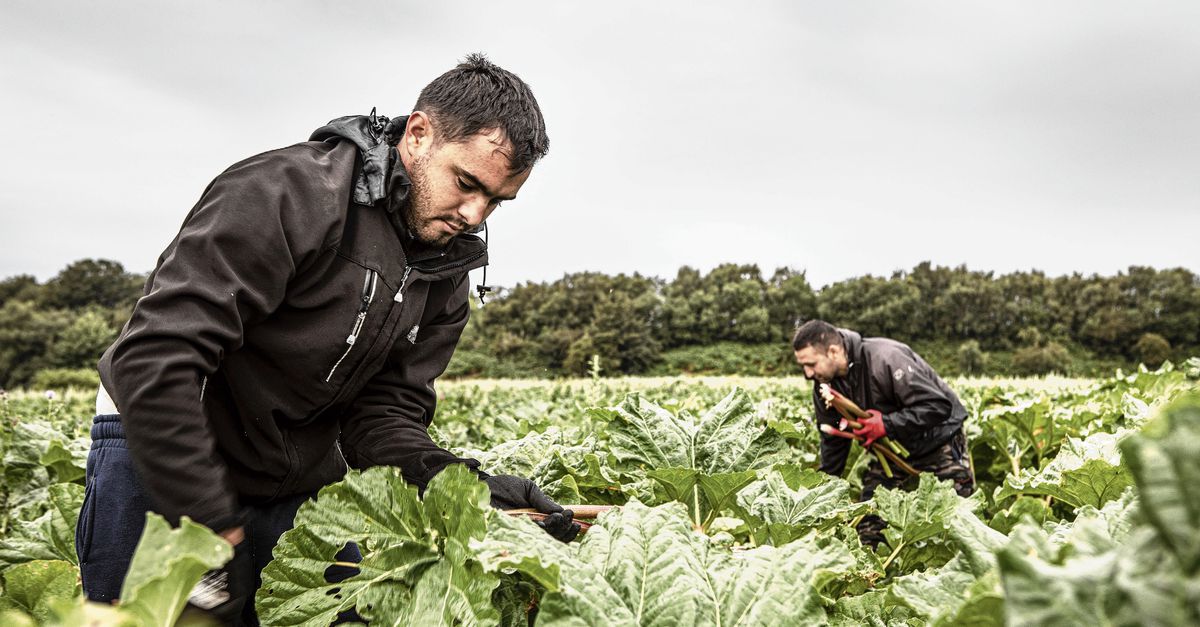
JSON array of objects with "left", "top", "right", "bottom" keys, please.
[{"left": 101, "top": 151, "right": 336, "bottom": 531}]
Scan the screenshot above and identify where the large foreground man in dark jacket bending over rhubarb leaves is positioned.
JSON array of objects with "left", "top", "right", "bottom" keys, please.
[{"left": 76, "top": 55, "right": 578, "bottom": 622}]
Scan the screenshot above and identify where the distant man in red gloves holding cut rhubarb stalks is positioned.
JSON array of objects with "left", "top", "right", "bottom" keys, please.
[{"left": 792, "top": 320, "right": 974, "bottom": 547}]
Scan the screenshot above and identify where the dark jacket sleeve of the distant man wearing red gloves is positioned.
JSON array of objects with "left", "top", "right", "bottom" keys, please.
[{"left": 872, "top": 352, "right": 954, "bottom": 442}]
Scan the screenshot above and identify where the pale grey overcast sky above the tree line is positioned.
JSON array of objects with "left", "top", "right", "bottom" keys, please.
[{"left": 0, "top": 0, "right": 1200, "bottom": 286}]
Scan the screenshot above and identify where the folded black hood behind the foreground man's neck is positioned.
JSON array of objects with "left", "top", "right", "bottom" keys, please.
[{"left": 308, "top": 109, "right": 408, "bottom": 205}]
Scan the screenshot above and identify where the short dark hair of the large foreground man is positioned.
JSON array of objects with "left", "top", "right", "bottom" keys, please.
[{"left": 413, "top": 53, "right": 550, "bottom": 172}]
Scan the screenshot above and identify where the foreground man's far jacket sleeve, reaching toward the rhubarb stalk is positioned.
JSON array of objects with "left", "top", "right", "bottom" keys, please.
[{"left": 341, "top": 275, "right": 479, "bottom": 491}]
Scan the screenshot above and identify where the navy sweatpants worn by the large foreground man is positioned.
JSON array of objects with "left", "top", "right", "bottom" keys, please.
[{"left": 76, "top": 414, "right": 362, "bottom": 625}]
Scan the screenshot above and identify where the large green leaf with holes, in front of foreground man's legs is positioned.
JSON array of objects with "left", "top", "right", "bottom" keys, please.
[{"left": 257, "top": 465, "right": 501, "bottom": 626}]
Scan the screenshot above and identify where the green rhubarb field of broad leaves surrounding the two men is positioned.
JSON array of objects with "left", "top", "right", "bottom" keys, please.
[{"left": 0, "top": 359, "right": 1200, "bottom": 626}]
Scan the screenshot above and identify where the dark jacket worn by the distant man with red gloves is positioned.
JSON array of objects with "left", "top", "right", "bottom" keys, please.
[{"left": 812, "top": 329, "right": 967, "bottom": 474}]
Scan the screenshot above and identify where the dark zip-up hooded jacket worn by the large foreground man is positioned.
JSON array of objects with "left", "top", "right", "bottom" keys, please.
[{"left": 100, "top": 117, "right": 487, "bottom": 530}]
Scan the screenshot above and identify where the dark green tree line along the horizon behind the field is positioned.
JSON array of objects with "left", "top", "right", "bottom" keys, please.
[{"left": 0, "top": 259, "right": 1200, "bottom": 388}]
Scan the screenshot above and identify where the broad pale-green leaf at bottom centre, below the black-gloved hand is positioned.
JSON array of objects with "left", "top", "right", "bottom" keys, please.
[{"left": 473, "top": 502, "right": 854, "bottom": 626}]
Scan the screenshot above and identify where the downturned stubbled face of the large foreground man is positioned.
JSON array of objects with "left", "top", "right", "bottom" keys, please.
[{"left": 403, "top": 125, "right": 530, "bottom": 246}]
